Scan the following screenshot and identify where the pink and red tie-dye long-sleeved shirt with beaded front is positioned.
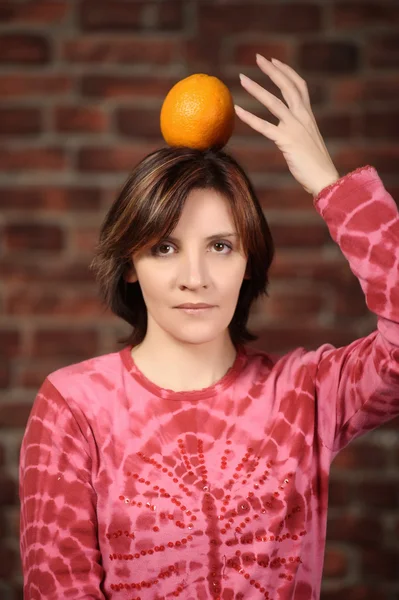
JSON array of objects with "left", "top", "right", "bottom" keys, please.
[{"left": 20, "top": 166, "right": 399, "bottom": 600}]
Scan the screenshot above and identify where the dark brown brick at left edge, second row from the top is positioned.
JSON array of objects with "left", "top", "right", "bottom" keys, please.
[{"left": 0, "top": 33, "right": 50, "bottom": 65}]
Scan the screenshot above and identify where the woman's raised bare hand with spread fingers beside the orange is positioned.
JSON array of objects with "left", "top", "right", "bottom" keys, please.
[{"left": 235, "top": 54, "right": 340, "bottom": 196}]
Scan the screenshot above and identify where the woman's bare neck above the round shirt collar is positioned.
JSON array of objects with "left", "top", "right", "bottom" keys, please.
[{"left": 132, "top": 331, "right": 237, "bottom": 392}]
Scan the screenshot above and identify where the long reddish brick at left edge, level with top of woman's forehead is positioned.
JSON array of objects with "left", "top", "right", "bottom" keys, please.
[{"left": 0, "top": 185, "right": 101, "bottom": 213}]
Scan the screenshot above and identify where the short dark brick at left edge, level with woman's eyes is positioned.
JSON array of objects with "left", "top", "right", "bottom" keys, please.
[{"left": 4, "top": 223, "right": 64, "bottom": 252}]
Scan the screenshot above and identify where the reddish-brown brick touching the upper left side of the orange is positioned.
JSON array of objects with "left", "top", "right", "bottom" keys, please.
[{"left": 81, "top": 75, "right": 177, "bottom": 100}]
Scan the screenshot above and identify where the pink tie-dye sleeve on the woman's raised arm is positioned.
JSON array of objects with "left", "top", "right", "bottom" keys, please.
[{"left": 306, "top": 166, "right": 399, "bottom": 453}]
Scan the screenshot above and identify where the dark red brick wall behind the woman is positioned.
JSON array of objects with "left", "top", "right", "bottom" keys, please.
[{"left": 0, "top": 0, "right": 399, "bottom": 600}]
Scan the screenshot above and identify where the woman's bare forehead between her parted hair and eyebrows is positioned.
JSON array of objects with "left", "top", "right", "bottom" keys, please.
[{"left": 174, "top": 189, "right": 235, "bottom": 233}]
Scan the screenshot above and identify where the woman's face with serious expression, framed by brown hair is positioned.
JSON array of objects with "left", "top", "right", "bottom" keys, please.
[{"left": 126, "top": 189, "right": 247, "bottom": 344}]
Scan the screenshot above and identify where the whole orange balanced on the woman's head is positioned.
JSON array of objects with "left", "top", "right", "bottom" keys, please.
[{"left": 161, "top": 73, "right": 235, "bottom": 150}]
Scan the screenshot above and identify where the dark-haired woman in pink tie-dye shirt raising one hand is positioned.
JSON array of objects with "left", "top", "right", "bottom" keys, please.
[{"left": 20, "top": 57, "right": 399, "bottom": 600}]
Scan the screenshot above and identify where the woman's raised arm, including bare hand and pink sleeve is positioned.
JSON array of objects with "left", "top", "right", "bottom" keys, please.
[{"left": 236, "top": 57, "right": 399, "bottom": 454}]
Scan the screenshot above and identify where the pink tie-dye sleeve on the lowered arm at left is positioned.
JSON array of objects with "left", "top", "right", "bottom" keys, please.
[{"left": 19, "top": 379, "right": 104, "bottom": 600}]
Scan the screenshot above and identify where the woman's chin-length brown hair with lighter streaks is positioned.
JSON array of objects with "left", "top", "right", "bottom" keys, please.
[{"left": 90, "top": 147, "right": 274, "bottom": 345}]
